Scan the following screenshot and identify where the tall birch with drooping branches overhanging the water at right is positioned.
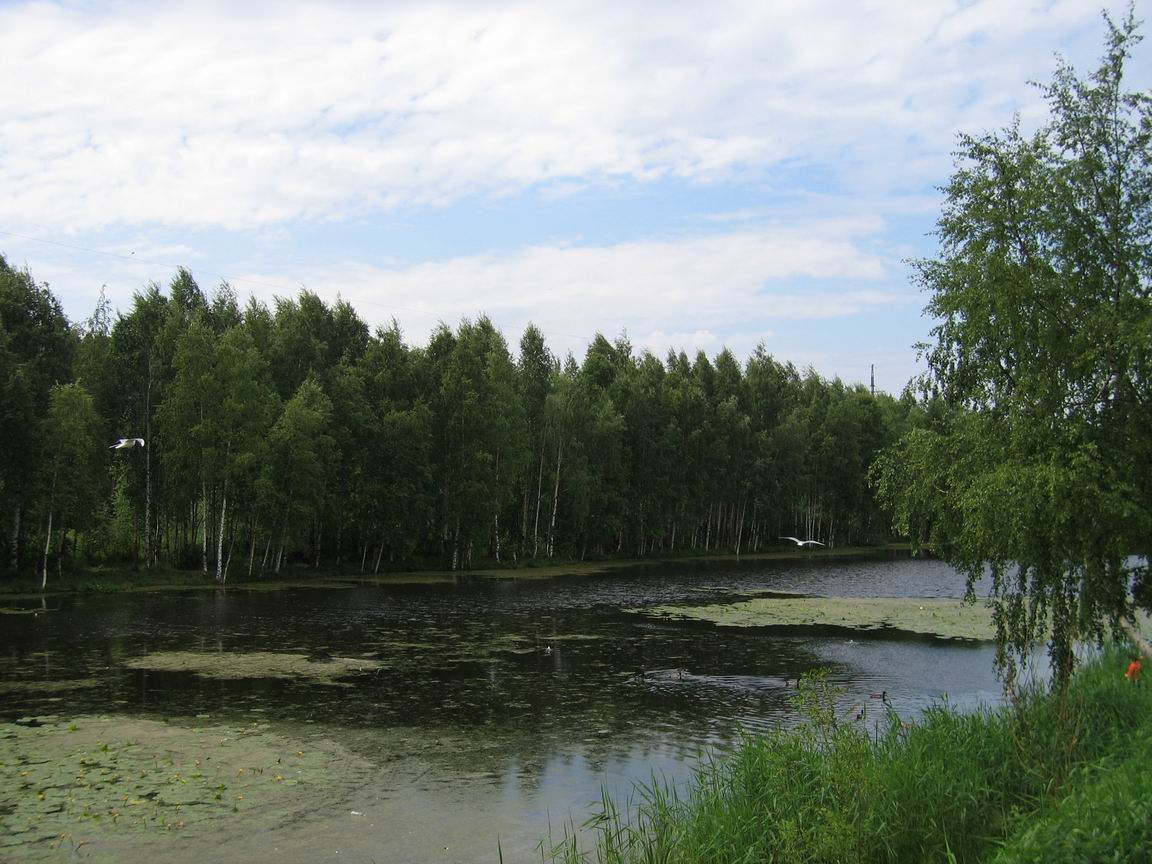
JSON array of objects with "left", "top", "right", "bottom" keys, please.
[{"left": 876, "top": 9, "right": 1152, "bottom": 683}]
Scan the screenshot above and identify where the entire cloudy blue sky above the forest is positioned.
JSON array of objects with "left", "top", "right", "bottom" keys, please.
[{"left": 0, "top": 0, "right": 1138, "bottom": 393}]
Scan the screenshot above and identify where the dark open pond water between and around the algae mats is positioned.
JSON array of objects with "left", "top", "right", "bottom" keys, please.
[{"left": 0, "top": 556, "right": 999, "bottom": 862}]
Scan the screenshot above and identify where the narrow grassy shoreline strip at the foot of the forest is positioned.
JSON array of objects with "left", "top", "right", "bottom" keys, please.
[{"left": 0, "top": 544, "right": 908, "bottom": 596}]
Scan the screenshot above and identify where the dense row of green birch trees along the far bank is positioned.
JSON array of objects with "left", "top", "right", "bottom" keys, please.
[{"left": 0, "top": 258, "right": 918, "bottom": 581}]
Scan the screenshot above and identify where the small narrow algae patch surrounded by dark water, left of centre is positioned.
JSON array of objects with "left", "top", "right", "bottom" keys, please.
[{"left": 124, "top": 651, "right": 387, "bottom": 684}]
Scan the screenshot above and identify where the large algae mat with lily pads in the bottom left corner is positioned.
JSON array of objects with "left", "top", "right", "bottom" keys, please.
[{"left": 0, "top": 717, "right": 367, "bottom": 861}]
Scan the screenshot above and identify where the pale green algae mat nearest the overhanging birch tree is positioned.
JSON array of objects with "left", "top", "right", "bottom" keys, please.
[{"left": 632, "top": 597, "right": 995, "bottom": 639}]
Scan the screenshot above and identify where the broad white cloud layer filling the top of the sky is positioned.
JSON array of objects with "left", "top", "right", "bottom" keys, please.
[{"left": 0, "top": 0, "right": 1098, "bottom": 230}]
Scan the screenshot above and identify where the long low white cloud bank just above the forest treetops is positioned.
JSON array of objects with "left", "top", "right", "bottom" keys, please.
[{"left": 209, "top": 220, "right": 898, "bottom": 357}]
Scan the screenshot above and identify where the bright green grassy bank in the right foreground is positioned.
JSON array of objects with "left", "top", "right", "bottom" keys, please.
[{"left": 551, "top": 649, "right": 1152, "bottom": 864}]
